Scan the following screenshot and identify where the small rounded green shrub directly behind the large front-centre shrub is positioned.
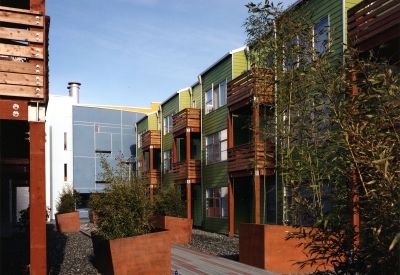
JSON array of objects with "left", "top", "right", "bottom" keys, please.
[{"left": 153, "top": 185, "right": 186, "bottom": 218}]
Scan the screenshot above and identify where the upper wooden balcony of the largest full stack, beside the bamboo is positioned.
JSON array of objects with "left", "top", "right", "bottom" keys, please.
[{"left": 227, "top": 69, "right": 274, "bottom": 111}]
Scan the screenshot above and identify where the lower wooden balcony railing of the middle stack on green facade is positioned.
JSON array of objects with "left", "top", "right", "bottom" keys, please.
[{"left": 172, "top": 159, "right": 201, "bottom": 184}]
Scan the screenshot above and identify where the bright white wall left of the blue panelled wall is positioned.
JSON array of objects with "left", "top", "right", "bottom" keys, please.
[{"left": 46, "top": 95, "right": 75, "bottom": 220}]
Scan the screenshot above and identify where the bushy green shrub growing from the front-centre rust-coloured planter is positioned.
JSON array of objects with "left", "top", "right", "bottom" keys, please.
[{"left": 89, "top": 155, "right": 152, "bottom": 240}]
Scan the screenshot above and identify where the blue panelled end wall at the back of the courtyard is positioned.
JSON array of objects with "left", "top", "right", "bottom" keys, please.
[{"left": 72, "top": 106, "right": 144, "bottom": 193}]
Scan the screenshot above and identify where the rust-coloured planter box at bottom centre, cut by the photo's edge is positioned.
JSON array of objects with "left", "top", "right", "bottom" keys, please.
[{"left": 92, "top": 231, "right": 171, "bottom": 275}]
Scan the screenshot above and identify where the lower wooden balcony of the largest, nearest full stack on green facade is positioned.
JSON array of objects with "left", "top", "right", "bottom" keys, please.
[{"left": 228, "top": 141, "right": 275, "bottom": 176}]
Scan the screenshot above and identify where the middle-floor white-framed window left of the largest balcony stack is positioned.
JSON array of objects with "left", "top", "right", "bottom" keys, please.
[{"left": 206, "top": 129, "right": 228, "bottom": 164}]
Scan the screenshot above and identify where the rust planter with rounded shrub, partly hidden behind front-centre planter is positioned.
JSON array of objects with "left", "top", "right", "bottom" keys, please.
[{"left": 150, "top": 185, "right": 193, "bottom": 244}]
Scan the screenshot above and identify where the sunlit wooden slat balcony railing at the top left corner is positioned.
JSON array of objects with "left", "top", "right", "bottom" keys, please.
[{"left": 0, "top": 6, "right": 50, "bottom": 101}]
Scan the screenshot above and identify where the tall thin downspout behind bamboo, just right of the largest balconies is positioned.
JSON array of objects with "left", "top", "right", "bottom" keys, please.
[{"left": 274, "top": 21, "right": 280, "bottom": 224}]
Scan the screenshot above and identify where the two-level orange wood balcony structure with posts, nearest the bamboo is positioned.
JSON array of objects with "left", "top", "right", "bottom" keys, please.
[{"left": 227, "top": 69, "right": 275, "bottom": 236}]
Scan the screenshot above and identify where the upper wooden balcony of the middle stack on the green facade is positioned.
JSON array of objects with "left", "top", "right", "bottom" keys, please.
[{"left": 172, "top": 108, "right": 201, "bottom": 136}]
